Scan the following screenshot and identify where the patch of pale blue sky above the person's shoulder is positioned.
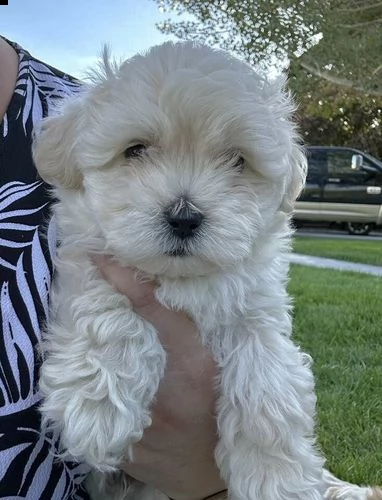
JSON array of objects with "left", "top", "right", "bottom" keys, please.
[{"left": 0, "top": 0, "right": 177, "bottom": 78}]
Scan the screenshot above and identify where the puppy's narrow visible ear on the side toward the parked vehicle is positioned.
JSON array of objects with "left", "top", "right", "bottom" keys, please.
[{"left": 280, "top": 144, "right": 307, "bottom": 213}]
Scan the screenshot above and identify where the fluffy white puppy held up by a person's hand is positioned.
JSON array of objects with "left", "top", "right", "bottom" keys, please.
[{"left": 34, "top": 43, "right": 380, "bottom": 500}]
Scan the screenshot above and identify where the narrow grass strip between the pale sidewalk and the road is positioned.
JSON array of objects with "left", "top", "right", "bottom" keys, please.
[{"left": 293, "top": 236, "right": 382, "bottom": 266}]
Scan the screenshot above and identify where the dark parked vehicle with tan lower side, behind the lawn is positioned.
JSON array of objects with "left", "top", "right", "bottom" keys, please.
[{"left": 294, "top": 146, "right": 382, "bottom": 234}]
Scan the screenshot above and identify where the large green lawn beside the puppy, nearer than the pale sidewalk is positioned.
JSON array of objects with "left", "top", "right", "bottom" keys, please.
[{"left": 289, "top": 268, "right": 382, "bottom": 484}]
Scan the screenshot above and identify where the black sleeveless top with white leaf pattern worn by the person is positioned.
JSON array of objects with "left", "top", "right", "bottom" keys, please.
[{"left": 0, "top": 36, "right": 88, "bottom": 500}]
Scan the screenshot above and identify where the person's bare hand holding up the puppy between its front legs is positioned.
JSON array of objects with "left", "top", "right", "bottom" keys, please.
[{"left": 94, "top": 257, "right": 225, "bottom": 500}]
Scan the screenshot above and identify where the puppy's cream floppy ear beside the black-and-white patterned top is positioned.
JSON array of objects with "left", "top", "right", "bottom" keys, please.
[{"left": 32, "top": 98, "right": 82, "bottom": 189}]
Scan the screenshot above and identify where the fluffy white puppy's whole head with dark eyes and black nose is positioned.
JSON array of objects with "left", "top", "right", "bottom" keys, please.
[{"left": 34, "top": 43, "right": 304, "bottom": 276}]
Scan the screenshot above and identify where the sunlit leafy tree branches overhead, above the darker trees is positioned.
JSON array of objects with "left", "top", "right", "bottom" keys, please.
[{"left": 154, "top": 0, "right": 382, "bottom": 96}]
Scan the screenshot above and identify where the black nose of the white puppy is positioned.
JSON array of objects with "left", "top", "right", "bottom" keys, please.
[{"left": 165, "top": 197, "right": 204, "bottom": 239}]
